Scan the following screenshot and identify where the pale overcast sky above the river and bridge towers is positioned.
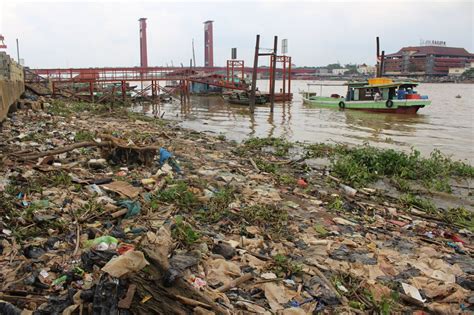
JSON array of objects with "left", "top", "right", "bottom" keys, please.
[{"left": 0, "top": 0, "right": 474, "bottom": 68}]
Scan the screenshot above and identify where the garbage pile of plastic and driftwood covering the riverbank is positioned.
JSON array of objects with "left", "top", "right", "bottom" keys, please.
[{"left": 0, "top": 100, "right": 474, "bottom": 314}]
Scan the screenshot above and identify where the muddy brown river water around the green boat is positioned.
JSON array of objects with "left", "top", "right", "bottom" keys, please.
[{"left": 139, "top": 81, "right": 474, "bottom": 164}]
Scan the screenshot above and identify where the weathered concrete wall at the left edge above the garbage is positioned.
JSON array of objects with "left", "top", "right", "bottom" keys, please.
[{"left": 0, "top": 52, "right": 25, "bottom": 122}]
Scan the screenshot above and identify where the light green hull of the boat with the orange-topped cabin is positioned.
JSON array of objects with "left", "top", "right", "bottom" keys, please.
[{"left": 303, "top": 97, "right": 431, "bottom": 114}]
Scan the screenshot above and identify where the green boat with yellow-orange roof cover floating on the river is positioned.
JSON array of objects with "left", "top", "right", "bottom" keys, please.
[{"left": 301, "top": 78, "right": 431, "bottom": 114}]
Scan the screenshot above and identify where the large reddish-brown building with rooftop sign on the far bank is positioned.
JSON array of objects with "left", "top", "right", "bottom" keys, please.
[{"left": 383, "top": 46, "right": 474, "bottom": 76}]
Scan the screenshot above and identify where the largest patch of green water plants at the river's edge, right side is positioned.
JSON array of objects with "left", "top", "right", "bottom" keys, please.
[{"left": 307, "top": 144, "right": 474, "bottom": 192}]
